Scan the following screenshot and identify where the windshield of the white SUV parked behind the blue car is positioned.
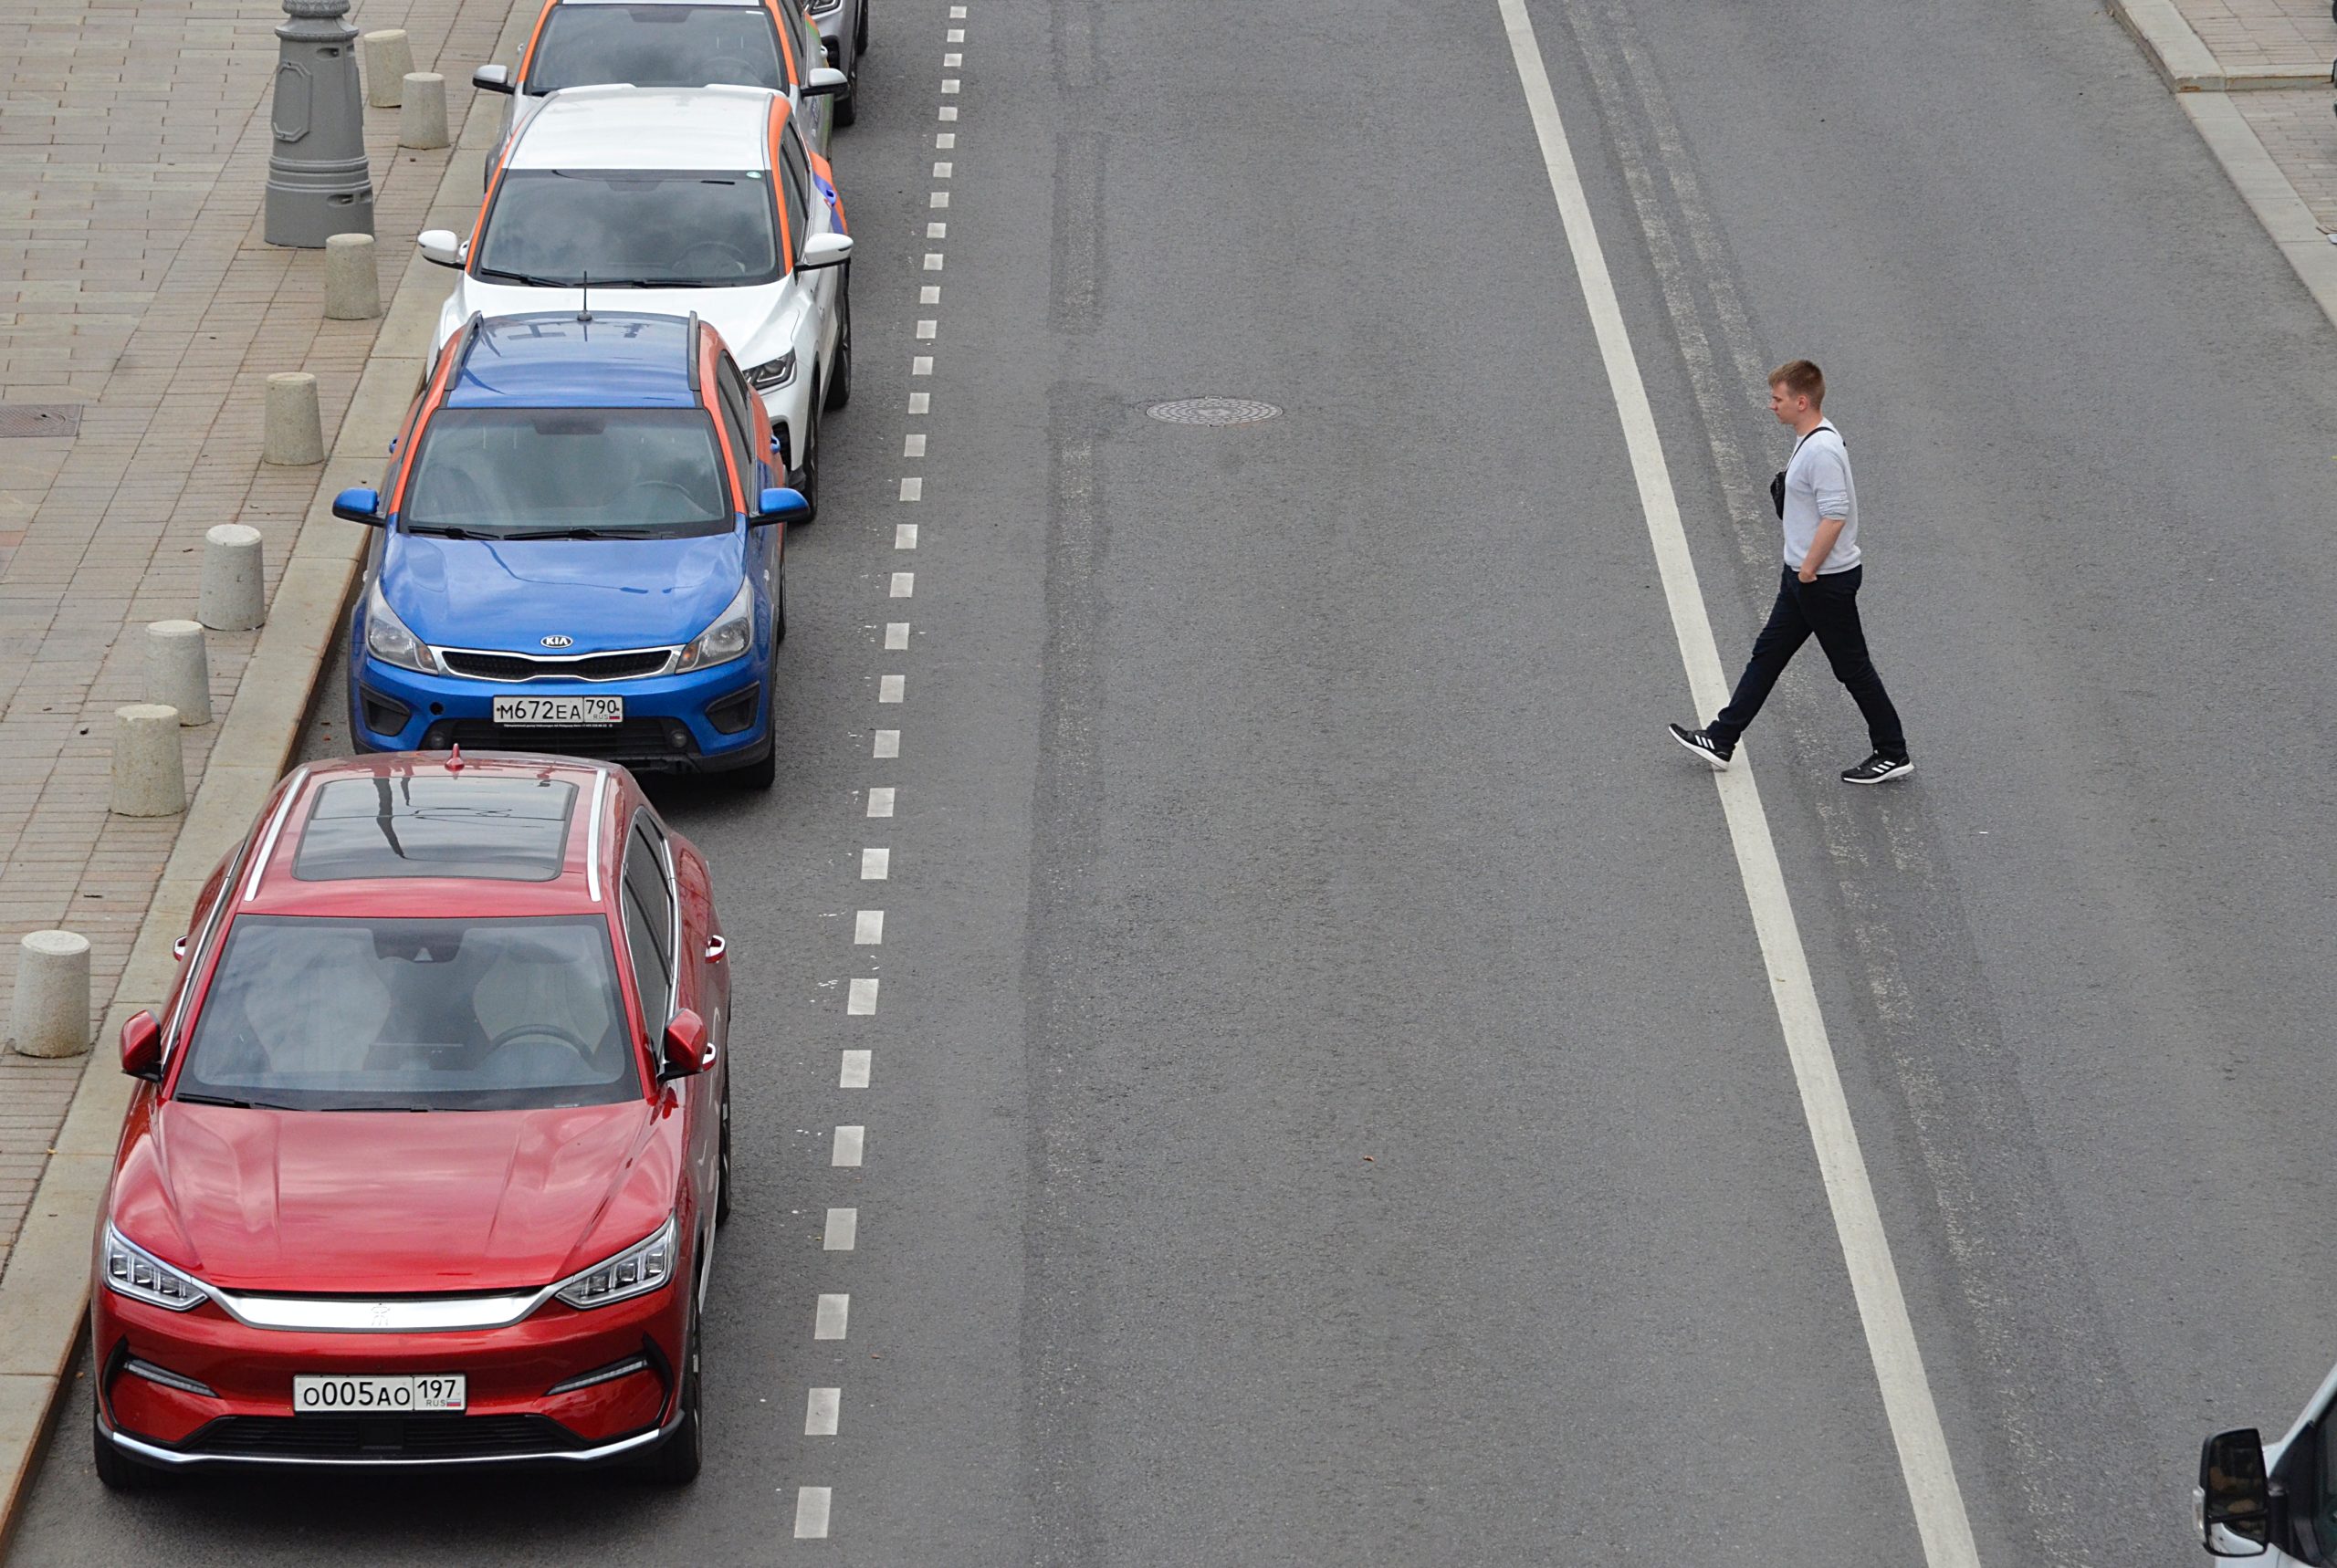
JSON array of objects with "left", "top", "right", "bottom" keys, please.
[{"left": 472, "top": 168, "right": 778, "bottom": 287}]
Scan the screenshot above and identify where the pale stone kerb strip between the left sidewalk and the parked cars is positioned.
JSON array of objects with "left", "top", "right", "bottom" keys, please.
[{"left": 0, "top": 7, "right": 535, "bottom": 1550}]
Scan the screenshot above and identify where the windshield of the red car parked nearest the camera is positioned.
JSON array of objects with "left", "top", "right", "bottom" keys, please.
[{"left": 173, "top": 916, "right": 640, "bottom": 1110}]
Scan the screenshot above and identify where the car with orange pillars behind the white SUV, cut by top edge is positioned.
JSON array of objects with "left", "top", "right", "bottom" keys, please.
[{"left": 470, "top": 0, "right": 858, "bottom": 178}]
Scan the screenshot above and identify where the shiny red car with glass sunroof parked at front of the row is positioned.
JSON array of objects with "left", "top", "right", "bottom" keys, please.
[{"left": 89, "top": 752, "right": 729, "bottom": 1489}]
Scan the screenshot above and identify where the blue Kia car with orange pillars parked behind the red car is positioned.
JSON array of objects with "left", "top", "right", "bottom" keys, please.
[{"left": 332, "top": 311, "right": 811, "bottom": 788}]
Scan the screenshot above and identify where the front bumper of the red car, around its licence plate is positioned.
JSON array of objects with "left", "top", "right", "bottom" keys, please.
[{"left": 89, "top": 1271, "right": 689, "bottom": 1468}]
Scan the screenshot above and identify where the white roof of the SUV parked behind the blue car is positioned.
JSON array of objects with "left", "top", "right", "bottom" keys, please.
[{"left": 508, "top": 87, "right": 776, "bottom": 168}]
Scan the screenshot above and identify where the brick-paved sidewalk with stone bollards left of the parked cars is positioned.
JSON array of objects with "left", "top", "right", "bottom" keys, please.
[{"left": 0, "top": 0, "right": 514, "bottom": 1271}]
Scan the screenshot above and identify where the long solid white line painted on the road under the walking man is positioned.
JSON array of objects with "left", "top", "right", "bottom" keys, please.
[{"left": 1501, "top": 0, "right": 1979, "bottom": 1568}]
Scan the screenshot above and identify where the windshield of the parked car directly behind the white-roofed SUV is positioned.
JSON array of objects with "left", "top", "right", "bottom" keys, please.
[{"left": 529, "top": 5, "right": 788, "bottom": 93}]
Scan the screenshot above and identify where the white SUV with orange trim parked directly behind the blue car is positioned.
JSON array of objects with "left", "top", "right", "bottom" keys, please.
[{"left": 418, "top": 87, "right": 853, "bottom": 500}]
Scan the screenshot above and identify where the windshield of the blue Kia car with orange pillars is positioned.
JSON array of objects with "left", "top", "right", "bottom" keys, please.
[{"left": 400, "top": 409, "right": 731, "bottom": 539}]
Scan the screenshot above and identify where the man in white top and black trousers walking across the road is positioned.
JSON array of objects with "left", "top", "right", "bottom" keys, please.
[{"left": 1671, "top": 360, "right": 1914, "bottom": 783}]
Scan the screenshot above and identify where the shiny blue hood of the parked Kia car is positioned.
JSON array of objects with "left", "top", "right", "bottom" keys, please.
[{"left": 381, "top": 528, "right": 746, "bottom": 654}]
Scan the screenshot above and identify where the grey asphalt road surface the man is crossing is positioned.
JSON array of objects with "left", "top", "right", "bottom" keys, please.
[{"left": 9, "top": 0, "right": 2337, "bottom": 1568}]
